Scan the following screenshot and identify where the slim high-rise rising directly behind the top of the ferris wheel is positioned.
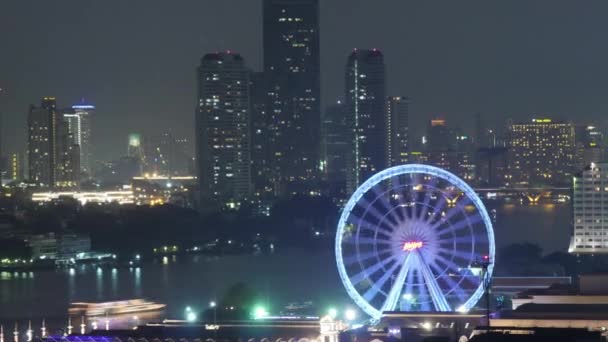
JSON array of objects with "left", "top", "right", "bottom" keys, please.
[{"left": 386, "top": 96, "right": 410, "bottom": 166}]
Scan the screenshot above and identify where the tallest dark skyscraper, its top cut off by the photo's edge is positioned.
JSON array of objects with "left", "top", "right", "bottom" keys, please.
[{"left": 263, "top": 0, "right": 321, "bottom": 194}]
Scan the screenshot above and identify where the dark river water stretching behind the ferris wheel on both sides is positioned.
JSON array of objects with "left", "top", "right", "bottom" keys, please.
[{"left": 0, "top": 204, "right": 571, "bottom": 329}]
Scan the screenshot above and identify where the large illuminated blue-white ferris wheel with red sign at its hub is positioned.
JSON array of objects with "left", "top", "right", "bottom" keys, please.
[{"left": 335, "top": 164, "right": 495, "bottom": 319}]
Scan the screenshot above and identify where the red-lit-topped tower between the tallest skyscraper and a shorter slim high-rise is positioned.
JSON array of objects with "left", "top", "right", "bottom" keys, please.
[{"left": 345, "top": 49, "right": 388, "bottom": 193}]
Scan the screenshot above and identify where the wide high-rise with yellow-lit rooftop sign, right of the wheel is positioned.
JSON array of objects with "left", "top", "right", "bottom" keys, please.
[{"left": 509, "top": 118, "right": 575, "bottom": 184}]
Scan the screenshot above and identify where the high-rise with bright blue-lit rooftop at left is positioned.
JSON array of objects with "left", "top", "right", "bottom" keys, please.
[{"left": 63, "top": 103, "right": 95, "bottom": 176}]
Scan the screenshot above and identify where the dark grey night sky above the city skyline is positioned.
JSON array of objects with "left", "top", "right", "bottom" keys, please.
[{"left": 0, "top": 0, "right": 608, "bottom": 158}]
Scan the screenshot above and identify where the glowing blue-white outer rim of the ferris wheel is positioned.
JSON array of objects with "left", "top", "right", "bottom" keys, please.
[{"left": 335, "top": 164, "right": 496, "bottom": 319}]
